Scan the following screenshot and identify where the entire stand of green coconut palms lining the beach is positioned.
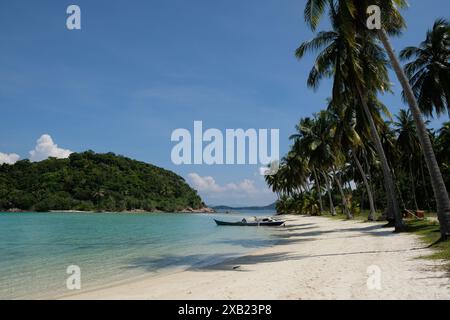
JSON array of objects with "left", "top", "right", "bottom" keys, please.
[{"left": 266, "top": 0, "right": 450, "bottom": 240}]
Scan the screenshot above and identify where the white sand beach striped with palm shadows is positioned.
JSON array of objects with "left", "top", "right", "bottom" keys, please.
[{"left": 65, "top": 216, "right": 450, "bottom": 300}]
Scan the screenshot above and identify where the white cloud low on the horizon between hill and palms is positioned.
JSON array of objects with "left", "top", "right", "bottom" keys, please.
[{"left": 188, "top": 173, "right": 276, "bottom": 206}]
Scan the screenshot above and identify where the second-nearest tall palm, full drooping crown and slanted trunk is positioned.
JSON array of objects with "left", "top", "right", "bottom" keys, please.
[{"left": 296, "top": 0, "right": 404, "bottom": 231}]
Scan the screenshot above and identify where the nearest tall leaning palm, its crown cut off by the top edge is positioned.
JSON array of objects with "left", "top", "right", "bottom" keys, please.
[{"left": 305, "top": 0, "right": 450, "bottom": 240}]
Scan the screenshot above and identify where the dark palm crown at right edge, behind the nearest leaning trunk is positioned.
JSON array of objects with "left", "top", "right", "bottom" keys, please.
[{"left": 400, "top": 19, "right": 450, "bottom": 116}]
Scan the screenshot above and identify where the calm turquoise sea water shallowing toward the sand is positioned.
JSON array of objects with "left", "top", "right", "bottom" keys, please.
[{"left": 0, "top": 212, "right": 277, "bottom": 299}]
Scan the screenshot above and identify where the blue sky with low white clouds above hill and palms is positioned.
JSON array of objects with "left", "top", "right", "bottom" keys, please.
[{"left": 0, "top": 0, "right": 450, "bottom": 205}]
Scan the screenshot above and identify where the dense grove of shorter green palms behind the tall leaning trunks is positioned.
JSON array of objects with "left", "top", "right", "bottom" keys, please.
[{"left": 267, "top": 110, "right": 450, "bottom": 220}]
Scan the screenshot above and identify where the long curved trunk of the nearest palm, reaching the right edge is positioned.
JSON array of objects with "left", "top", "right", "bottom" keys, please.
[{"left": 378, "top": 29, "right": 450, "bottom": 240}]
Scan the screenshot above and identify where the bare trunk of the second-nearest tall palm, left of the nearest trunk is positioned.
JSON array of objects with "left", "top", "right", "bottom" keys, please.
[{"left": 356, "top": 84, "right": 404, "bottom": 232}]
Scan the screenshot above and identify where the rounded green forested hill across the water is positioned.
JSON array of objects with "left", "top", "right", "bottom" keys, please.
[{"left": 0, "top": 151, "right": 203, "bottom": 211}]
